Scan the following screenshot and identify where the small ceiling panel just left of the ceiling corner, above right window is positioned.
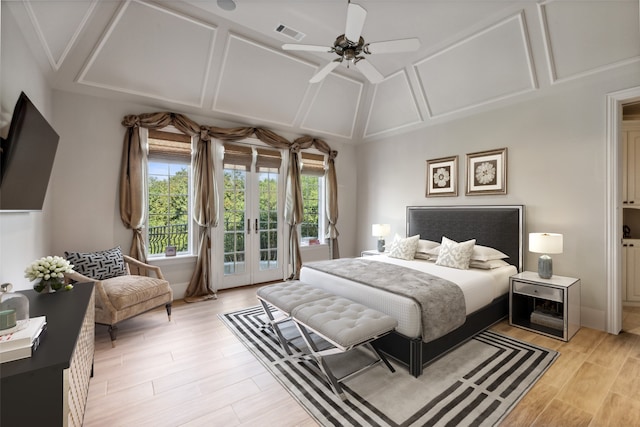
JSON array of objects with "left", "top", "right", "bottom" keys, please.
[{"left": 301, "top": 74, "right": 364, "bottom": 138}]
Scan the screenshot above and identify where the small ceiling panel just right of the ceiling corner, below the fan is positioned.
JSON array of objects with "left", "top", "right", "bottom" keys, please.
[{"left": 365, "top": 70, "right": 422, "bottom": 137}]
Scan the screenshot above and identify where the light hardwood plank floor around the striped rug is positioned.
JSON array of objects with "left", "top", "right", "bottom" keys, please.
[{"left": 84, "top": 286, "right": 640, "bottom": 427}]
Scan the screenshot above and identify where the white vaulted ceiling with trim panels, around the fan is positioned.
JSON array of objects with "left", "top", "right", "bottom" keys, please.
[{"left": 2, "top": 0, "right": 640, "bottom": 143}]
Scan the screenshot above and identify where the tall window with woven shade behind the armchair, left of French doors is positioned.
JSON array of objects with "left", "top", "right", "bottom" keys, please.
[{"left": 147, "top": 130, "right": 192, "bottom": 256}]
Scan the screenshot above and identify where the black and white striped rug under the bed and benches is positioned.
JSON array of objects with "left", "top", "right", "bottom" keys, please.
[{"left": 220, "top": 306, "right": 558, "bottom": 426}]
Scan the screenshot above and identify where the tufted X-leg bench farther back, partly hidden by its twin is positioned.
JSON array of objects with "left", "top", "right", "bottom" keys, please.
[{"left": 256, "top": 280, "right": 332, "bottom": 355}]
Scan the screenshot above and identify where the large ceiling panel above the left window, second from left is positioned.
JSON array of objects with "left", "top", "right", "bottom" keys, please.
[{"left": 78, "top": 1, "right": 216, "bottom": 107}]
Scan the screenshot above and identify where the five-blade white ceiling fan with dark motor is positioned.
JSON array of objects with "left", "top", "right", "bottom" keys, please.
[{"left": 282, "top": 2, "right": 420, "bottom": 84}]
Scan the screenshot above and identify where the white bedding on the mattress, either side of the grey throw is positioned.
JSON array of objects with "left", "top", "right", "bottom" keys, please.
[{"left": 300, "top": 255, "right": 517, "bottom": 338}]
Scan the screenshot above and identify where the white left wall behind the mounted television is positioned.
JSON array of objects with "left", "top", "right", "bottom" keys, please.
[{"left": 0, "top": 2, "right": 59, "bottom": 290}]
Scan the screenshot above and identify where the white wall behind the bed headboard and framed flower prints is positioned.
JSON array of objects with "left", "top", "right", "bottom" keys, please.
[{"left": 357, "top": 63, "right": 640, "bottom": 330}]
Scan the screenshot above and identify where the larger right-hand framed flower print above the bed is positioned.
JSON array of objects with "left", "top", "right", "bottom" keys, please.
[{"left": 466, "top": 148, "right": 507, "bottom": 196}]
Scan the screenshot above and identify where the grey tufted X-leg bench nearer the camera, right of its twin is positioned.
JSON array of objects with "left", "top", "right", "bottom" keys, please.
[{"left": 291, "top": 295, "right": 398, "bottom": 400}]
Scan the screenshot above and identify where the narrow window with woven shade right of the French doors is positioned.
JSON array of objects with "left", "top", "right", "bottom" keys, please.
[{"left": 300, "top": 152, "right": 326, "bottom": 246}]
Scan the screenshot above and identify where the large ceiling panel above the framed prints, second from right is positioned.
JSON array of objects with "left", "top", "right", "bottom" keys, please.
[{"left": 415, "top": 13, "right": 537, "bottom": 117}]
